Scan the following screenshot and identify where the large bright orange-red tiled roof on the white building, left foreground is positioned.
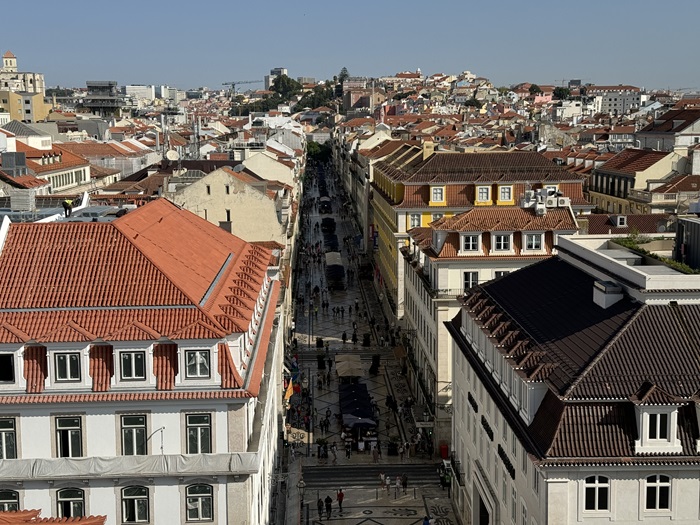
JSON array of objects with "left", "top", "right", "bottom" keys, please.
[{"left": 0, "top": 199, "right": 270, "bottom": 342}]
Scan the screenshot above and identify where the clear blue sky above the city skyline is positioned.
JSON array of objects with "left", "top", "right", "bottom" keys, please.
[{"left": 5, "top": 0, "right": 700, "bottom": 89}]
